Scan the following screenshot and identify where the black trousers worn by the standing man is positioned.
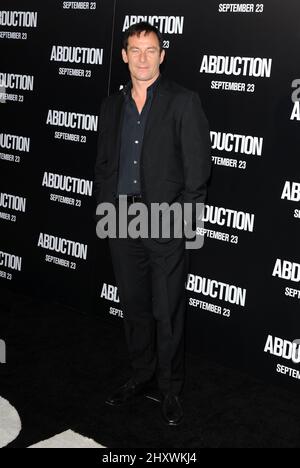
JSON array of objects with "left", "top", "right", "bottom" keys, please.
[{"left": 109, "top": 208, "right": 189, "bottom": 394}]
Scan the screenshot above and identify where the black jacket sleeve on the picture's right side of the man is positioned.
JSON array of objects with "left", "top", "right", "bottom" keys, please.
[{"left": 181, "top": 92, "right": 212, "bottom": 207}]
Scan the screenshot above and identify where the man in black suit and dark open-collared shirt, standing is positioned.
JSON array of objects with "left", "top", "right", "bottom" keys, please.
[{"left": 95, "top": 22, "right": 211, "bottom": 425}]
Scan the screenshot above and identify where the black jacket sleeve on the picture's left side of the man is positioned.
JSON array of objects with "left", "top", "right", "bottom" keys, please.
[{"left": 93, "top": 98, "right": 107, "bottom": 202}]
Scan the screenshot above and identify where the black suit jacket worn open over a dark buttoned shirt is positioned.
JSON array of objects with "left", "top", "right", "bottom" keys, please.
[{"left": 94, "top": 76, "right": 212, "bottom": 223}]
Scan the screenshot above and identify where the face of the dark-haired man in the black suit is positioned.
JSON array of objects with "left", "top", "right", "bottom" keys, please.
[{"left": 122, "top": 32, "right": 165, "bottom": 81}]
